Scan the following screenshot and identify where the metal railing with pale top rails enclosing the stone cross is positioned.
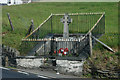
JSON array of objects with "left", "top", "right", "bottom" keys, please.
[{"left": 21, "top": 13, "right": 105, "bottom": 60}]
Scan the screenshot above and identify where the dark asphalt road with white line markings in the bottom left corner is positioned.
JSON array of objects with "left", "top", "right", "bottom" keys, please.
[{"left": 0, "top": 68, "right": 52, "bottom": 80}]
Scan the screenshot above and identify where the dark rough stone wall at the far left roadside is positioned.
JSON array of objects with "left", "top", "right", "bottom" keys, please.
[{"left": 0, "top": 44, "right": 20, "bottom": 67}]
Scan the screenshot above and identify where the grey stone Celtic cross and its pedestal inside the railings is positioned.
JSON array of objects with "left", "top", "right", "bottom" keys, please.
[{"left": 56, "top": 13, "right": 76, "bottom": 53}]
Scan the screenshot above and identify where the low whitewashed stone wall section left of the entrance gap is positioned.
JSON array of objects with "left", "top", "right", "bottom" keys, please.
[{"left": 16, "top": 58, "right": 44, "bottom": 68}]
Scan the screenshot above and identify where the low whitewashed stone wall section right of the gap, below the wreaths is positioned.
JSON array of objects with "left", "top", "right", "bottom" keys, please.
[{"left": 56, "top": 60, "right": 84, "bottom": 76}]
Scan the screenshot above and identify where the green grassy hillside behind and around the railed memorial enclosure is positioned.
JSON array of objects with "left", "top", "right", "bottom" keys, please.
[{"left": 2, "top": 2, "right": 120, "bottom": 77}]
